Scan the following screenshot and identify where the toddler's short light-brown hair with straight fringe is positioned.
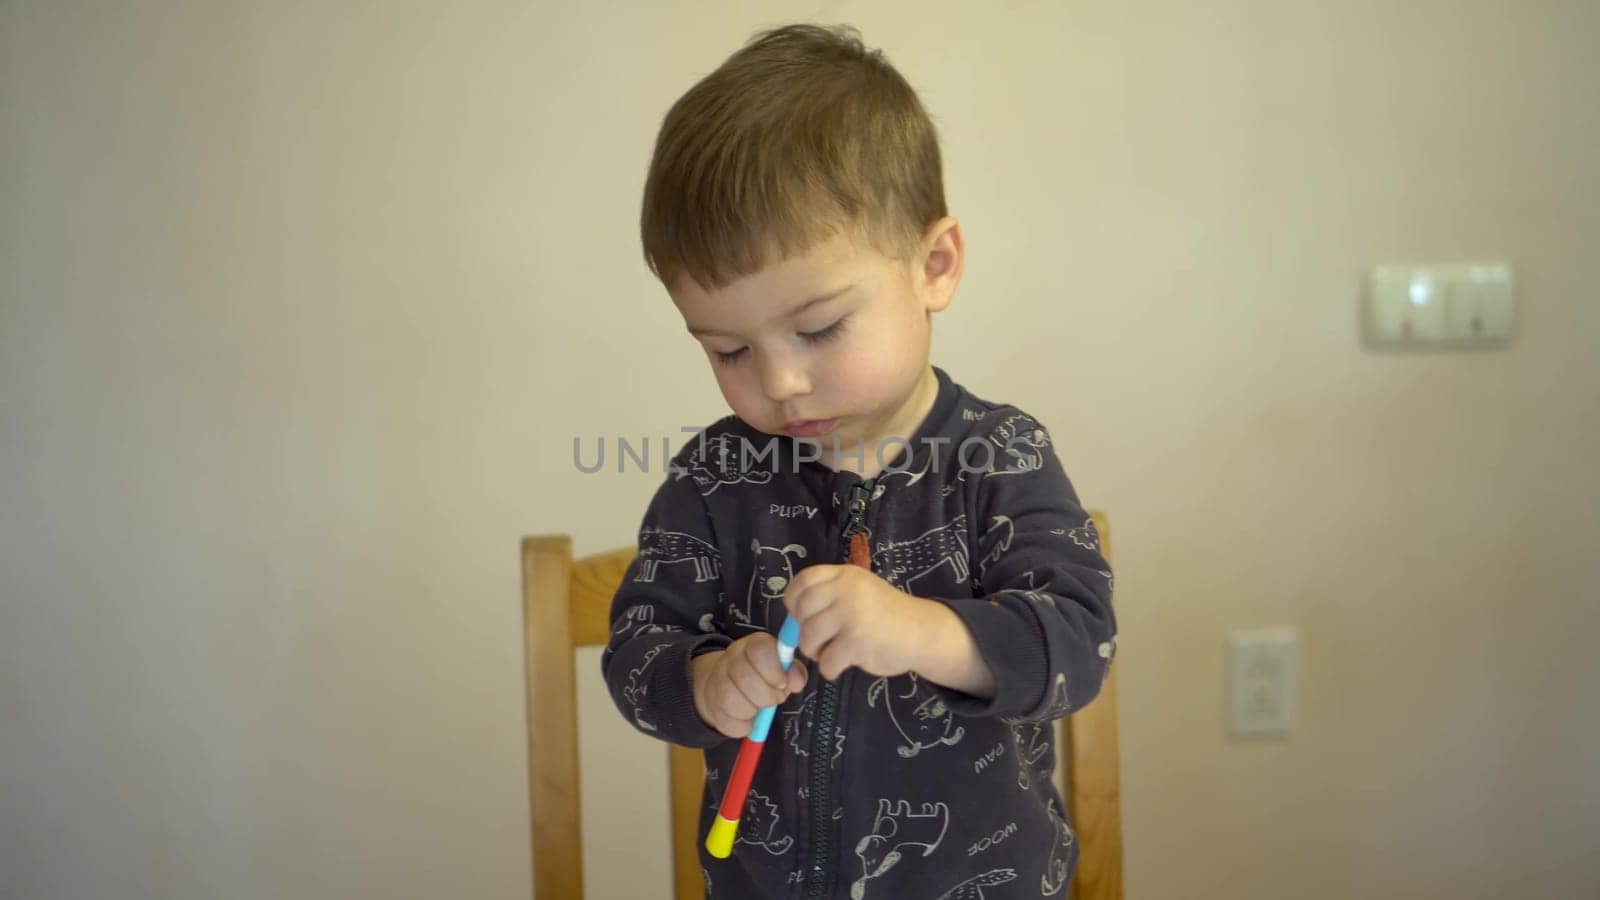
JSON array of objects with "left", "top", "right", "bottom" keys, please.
[{"left": 640, "top": 24, "right": 946, "bottom": 290}]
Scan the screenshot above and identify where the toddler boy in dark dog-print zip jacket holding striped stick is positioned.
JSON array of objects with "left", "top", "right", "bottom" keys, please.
[{"left": 602, "top": 26, "right": 1115, "bottom": 900}]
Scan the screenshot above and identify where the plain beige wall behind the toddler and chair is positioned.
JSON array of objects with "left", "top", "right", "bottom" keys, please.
[{"left": 0, "top": 0, "right": 1600, "bottom": 900}]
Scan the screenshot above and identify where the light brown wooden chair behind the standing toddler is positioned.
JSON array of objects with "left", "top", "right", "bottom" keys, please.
[{"left": 522, "top": 512, "right": 1122, "bottom": 900}]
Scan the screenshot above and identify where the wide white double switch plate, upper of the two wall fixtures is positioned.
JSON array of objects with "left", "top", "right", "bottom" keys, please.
[{"left": 1366, "top": 263, "right": 1517, "bottom": 348}]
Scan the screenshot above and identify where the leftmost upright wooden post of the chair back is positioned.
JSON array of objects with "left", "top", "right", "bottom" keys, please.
[{"left": 522, "top": 536, "right": 584, "bottom": 900}]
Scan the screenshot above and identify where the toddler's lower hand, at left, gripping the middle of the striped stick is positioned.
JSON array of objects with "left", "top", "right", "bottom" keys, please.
[{"left": 690, "top": 631, "right": 806, "bottom": 738}]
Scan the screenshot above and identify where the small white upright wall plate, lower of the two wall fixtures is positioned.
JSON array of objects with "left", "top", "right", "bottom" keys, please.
[{"left": 1227, "top": 628, "right": 1299, "bottom": 737}]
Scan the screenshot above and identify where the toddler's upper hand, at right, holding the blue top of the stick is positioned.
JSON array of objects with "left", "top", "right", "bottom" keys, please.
[{"left": 784, "top": 564, "right": 938, "bottom": 681}]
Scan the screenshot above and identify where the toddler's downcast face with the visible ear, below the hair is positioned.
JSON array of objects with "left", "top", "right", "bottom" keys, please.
[{"left": 669, "top": 218, "right": 962, "bottom": 469}]
